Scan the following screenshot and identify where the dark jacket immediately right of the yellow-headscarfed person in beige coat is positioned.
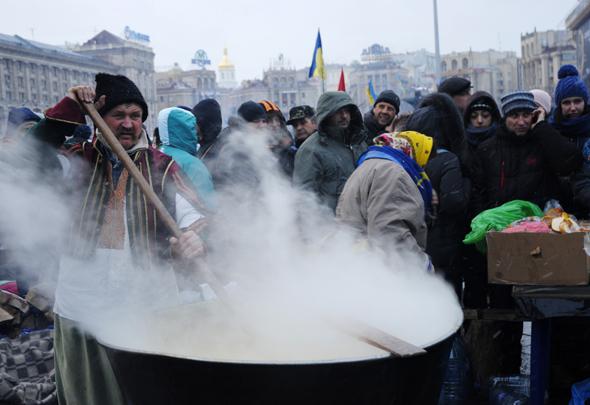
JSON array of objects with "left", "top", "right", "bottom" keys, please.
[{"left": 425, "top": 149, "right": 471, "bottom": 269}]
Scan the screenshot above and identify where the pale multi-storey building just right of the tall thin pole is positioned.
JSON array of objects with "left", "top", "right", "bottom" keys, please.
[{"left": 441, "top": 50, "right": 520, "bottom": 100}]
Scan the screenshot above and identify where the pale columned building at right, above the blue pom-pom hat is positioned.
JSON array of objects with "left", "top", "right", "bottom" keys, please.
[{"left": 520, "top": 30, "right": 577, "bottom": 94}]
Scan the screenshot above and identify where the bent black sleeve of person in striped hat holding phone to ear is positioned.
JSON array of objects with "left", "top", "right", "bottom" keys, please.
[{"left": 533, "top": 121, "right": 583, "bottom": 176}]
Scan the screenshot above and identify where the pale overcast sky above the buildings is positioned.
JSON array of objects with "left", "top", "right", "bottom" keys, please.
[{"left": 0, "top": 0, "right": 577, "bottom": 80}]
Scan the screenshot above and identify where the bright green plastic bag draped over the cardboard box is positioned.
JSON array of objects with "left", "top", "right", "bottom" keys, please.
[{"left": 463, "top": 200, "right": 543, "bottom": 253}]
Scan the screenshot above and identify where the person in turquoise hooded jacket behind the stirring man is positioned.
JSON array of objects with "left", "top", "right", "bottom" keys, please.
[{"left": 158, "top": 107, "right": 216, "bottom": 210}]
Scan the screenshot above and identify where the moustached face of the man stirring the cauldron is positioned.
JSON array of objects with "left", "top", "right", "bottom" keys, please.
[{"left": 103, "top": 103, "right": 143, "bottom": 149}]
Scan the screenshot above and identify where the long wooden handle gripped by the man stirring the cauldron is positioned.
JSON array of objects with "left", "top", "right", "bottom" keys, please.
[{"left": 81, "top": 103, "right": 229, "bottom": 304}]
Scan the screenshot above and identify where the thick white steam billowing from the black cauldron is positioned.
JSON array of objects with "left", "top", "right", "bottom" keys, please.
[{"left": 0, "top": 128, "right": 461, "bottom": 361}]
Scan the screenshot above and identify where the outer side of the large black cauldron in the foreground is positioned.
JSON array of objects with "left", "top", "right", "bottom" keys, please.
[{"left": 103, "top": 336, "right": 453, "bottom": 405}]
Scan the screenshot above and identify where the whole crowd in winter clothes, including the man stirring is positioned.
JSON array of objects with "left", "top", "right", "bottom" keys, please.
[{"left": 2, "top": 65, "right": 590, "bottom": 404}]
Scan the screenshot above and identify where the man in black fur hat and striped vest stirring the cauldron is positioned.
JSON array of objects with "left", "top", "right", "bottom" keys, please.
[{"left": 35, "top": 73, "right": 209, "bottom": 405}]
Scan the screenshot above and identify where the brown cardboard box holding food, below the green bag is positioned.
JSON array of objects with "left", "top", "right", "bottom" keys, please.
[{"left": 486, "top": 232, "right": 590, "bottom": 286}]
